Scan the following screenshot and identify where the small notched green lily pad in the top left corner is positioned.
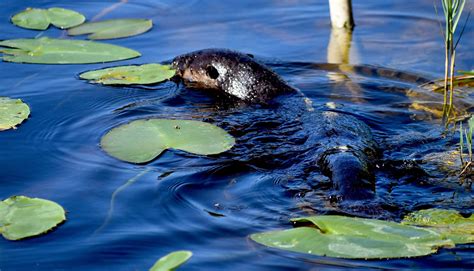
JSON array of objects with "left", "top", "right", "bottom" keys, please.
[{"left": 12, "top": 8, "right": 86, "bottom": 30}]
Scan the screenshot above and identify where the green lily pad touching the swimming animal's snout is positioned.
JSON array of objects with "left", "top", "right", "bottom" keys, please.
[{"left": 79, "top": 64, "right": 176, "bottom": 85}]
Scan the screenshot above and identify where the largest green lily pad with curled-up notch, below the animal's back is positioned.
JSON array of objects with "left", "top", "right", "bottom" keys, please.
[{"left": 250, "top": 215, "right": 454, "bottom": 259}]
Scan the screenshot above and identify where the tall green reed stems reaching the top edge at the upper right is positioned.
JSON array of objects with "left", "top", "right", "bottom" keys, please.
[{"left": 435, "top": 0, "right": 470, "bottom": 120}]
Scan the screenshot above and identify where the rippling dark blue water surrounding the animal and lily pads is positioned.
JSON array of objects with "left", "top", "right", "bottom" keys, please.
[{"left": 0, "top": 0, "right": 474, "bottom": 271}]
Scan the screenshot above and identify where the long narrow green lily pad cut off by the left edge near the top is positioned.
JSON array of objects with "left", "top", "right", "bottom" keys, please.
[{"left": 0, "top": 37, "right": 140, "bottom": 64}]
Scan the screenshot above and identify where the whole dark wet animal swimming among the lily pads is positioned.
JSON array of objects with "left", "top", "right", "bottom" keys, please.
[{"left": 172, "top": 49, "right": 378, "bottom": 199}]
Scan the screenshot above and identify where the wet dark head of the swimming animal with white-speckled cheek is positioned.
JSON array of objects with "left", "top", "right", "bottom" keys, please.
[{"left": 171, "top": 49, "right": 294, "bottom": 103}]
